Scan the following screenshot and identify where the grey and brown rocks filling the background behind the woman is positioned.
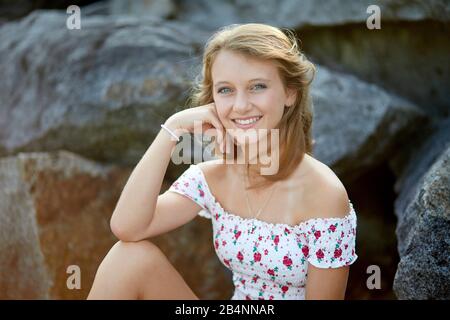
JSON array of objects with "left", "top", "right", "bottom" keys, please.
[{"left": 0, "top": 0, "right": 450, "bottom": 299}]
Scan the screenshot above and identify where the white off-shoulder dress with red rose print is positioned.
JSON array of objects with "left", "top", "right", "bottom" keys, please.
[{"left": 169, "top": 164, "right": 358, "bottom": 300}]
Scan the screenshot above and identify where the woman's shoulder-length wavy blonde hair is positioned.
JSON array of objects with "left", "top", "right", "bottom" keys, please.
[{"left": 188, "top": 23, "right": 316, "bottom": 187}]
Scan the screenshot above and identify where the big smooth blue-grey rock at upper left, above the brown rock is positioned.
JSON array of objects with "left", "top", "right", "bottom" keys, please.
[{"left": 0, "top": 11, "right": 208, "bottom": 168}]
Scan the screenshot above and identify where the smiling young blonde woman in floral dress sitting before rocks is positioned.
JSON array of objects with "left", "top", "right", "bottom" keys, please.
[{"left": 88, "top": 24, "right": 357, "bottom": 299}]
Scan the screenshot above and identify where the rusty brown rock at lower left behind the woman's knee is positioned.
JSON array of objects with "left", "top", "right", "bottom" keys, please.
[{"left": 0, "top": 151, "right": 232, "bottom": 299}]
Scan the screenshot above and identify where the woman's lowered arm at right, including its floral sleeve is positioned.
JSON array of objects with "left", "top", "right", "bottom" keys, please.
[{"left": 305, "top": 178, "right": 357, "bottom": 300}]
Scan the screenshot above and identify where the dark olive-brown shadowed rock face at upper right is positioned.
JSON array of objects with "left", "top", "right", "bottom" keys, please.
[{"left": 297, "top": 20, "right": 450, "bottom": 118}]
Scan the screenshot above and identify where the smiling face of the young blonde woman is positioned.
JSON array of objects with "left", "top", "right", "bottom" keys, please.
[{"left": 211, "top": 50, "right": 295, "bottom": 143}]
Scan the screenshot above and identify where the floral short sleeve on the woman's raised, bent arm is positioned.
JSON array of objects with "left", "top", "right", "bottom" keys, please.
[{"left": 168, "top": 165, "right": 211, "bottom": 219}]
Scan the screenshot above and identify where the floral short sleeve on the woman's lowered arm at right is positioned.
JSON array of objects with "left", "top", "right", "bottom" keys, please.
[{"left": 308, "top": 202, "right": 358, "bottom": 268}]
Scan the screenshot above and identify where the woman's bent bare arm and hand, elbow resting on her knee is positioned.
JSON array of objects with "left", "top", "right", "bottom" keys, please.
[{"left": 110, "top": 104, "right": 223, "bottom": 241}]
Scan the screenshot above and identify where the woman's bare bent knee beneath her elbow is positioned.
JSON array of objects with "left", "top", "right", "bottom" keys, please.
[{"left": 87, "top": 240, "right": 199, "bottom": 300}]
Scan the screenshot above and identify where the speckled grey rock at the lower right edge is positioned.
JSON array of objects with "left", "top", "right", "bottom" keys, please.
[{"left": 394, "top": 120, "right": 450, "bottom": 299}]
